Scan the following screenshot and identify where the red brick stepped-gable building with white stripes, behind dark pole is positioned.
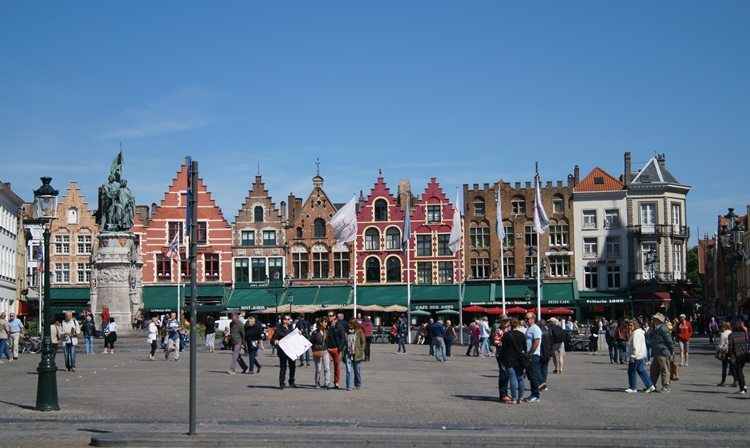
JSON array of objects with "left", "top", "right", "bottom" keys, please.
[{"left": 130, "top": 163, "right": 232, "bottom": 312}]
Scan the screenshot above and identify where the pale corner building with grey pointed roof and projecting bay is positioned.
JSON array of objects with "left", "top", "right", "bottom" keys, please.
[{"left": 623, "top": 152, "right": 695, "bottom": 314}]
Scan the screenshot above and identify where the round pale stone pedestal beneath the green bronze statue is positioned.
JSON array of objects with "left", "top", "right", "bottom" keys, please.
[{"left": 90, "top": 232, "right": 143, "bottom": 335}]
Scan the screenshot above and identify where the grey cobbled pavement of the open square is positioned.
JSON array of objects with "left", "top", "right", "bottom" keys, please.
[{"left": 0, "top": 336, "right": 750, "bottom": 448}]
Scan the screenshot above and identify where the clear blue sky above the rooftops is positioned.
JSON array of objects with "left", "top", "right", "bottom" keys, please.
[{"left": 0, "top": 1, "right": 750, "bottom": 244}]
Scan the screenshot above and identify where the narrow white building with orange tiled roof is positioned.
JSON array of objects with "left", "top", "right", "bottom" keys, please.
[{"left": 573, "top": 167, "right": 632, "bottom": 319}]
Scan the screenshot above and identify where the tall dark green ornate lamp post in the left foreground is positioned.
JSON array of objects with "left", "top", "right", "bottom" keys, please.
[{"left": 34, "top": 177, "right": 60, "bottom": 411}]
